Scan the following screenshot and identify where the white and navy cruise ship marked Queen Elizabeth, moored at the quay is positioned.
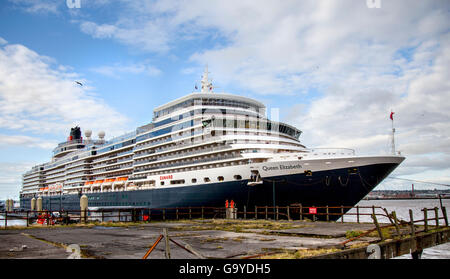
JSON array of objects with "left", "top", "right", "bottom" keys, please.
[{"left": 20, "top": 69, "right": 405, "bottom": 219}]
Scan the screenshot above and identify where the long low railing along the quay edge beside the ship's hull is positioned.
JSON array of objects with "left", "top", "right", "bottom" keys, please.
[{"left": 0, "top": 204, "right": 448, "bottom": 230}]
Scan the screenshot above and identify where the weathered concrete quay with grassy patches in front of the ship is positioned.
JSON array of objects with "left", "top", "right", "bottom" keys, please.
[{"left": 0, "top": 219, "right": 377, "bottom": 259}]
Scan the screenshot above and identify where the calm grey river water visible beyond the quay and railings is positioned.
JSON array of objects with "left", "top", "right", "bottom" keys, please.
[{"left": 0, "top": 199, "right": 450, "bottom": 259}]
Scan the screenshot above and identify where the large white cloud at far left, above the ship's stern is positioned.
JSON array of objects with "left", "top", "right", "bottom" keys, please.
[{"left": 0, "top": 44, "right": 127, "bottom": 138}]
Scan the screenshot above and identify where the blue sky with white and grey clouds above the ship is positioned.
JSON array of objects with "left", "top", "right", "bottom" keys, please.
[{"left": 0, "top": 0, "right": 450, "bottom": 199}]
